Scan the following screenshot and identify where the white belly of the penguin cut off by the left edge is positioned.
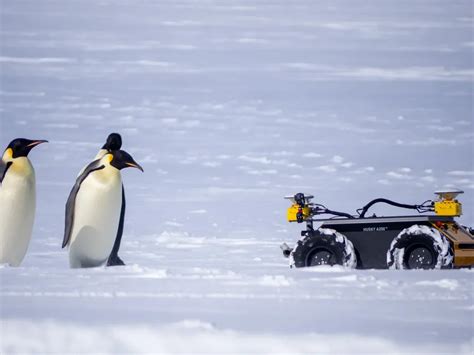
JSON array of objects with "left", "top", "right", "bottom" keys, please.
[{"left": 0, "top": 168, "right": 36, "bottom": 266}]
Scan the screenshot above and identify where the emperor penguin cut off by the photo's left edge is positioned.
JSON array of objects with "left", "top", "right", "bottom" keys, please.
[{"left": 0, "top": 138, "right": 47, "bottom": 266}]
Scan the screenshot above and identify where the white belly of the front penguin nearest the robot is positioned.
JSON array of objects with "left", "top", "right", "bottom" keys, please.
[{"left": 69, "top": 171, "right": 122, "bottom": 268}]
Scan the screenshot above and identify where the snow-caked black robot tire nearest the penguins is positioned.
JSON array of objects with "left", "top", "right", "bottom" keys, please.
[{"left": 290, "top": 228, "right": 357, "bottom": 268}]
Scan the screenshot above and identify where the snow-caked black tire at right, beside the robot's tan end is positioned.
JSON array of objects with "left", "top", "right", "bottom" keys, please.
[{"left": 387, "top": 225, "right": 454, "bottom": 269}]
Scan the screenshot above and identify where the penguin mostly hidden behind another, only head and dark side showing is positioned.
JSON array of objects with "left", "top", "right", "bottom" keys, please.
[{"left": 79, "top": 133, "right": 126, "bottom": 266}]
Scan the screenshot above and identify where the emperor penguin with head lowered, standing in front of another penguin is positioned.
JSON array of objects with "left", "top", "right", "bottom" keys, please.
[{"left": 62, "top": 150, "right": 143, "bottom": 268}]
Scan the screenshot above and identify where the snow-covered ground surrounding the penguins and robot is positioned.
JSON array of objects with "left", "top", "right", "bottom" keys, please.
[{"left": 0, "top": 0, "right": 474, "bottom": 354}]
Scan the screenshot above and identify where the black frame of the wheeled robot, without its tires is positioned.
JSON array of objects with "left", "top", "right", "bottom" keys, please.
[{"left": 281, "top": 193, "right": 474, "bottom": 269}]
